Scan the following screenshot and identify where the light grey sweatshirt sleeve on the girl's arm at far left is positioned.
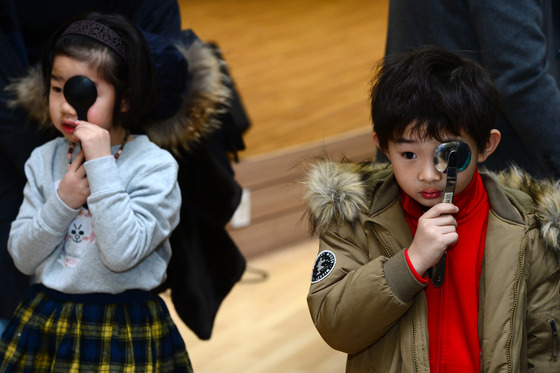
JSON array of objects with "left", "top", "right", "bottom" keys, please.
[{"left": 8, "top": 152, "right": 79, "bottom": 275}]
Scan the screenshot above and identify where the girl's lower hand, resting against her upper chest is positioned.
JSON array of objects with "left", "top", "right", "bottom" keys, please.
[{"left": 58, "top": 150, "right": 90, "bottom": 210}]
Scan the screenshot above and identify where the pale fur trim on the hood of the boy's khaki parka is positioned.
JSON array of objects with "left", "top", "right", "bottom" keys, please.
[{"left": 303, "top": 159, "right": 560, "bottom": 255}]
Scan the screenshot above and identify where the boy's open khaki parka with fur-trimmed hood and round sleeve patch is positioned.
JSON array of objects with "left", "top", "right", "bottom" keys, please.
[{"left": 306, "top": 160, "right": 560, "bottom": 373}]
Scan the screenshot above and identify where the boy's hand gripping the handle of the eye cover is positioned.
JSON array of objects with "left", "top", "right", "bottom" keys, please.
[{"left": 408, "top": 203, "right": 459, "bottom": 276}]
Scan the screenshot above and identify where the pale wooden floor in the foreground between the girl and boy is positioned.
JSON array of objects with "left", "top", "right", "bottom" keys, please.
[{"left": 161, "top": 241, "right": 346, "bottom": 373}]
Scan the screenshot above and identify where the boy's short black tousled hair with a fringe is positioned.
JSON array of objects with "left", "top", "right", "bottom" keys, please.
[{"left": 370, "top": 47, "right": 499, "bottom": 151}]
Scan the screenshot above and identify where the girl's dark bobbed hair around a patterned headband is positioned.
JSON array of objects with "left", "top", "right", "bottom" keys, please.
[{"left": 41, "top": 13, "right": 157, "bottom": 129}]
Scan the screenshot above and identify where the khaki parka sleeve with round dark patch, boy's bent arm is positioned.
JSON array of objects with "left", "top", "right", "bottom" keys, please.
[{"left": 307, "top": 224, "right": 424, "bottom": 354}]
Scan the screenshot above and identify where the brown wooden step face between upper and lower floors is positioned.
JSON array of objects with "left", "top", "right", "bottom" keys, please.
[{"left": 228, "top": 127, "right": 374, "bottom": 257}]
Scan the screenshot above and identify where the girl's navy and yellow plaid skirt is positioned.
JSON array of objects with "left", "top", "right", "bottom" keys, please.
[{"left": 0, "top": 285, "right": 192, "bottom": 373}]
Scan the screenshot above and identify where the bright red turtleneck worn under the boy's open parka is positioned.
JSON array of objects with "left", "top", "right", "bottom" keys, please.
[{"left": 400, "top": 171, "right": 490, "bottom": 372}]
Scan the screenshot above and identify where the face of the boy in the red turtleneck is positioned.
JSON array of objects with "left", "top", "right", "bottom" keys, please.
[{"left": 374, "top": 129, "right": 499, "bottom": 208}]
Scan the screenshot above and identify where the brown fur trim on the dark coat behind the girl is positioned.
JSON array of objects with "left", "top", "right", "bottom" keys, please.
[{"left": 6, "top": 30, "right": 231, "bottom": 153}]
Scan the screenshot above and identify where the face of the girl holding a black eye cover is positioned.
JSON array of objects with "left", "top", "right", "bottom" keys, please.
[{"left": 49, "top": 55, "right": 123, "bottom": 145}]
